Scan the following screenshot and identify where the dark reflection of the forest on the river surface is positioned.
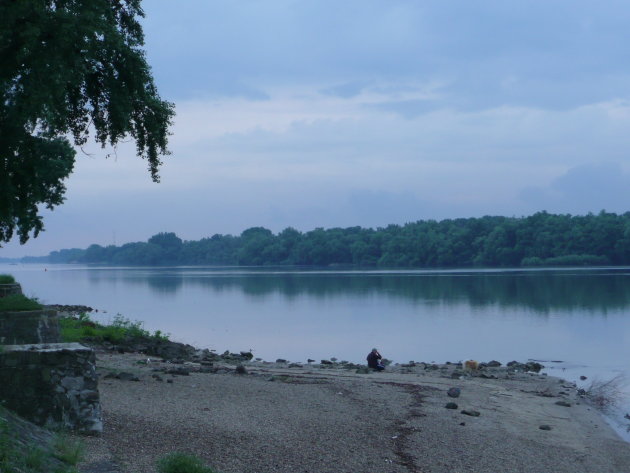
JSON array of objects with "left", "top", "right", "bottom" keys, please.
[{"left": 81, "top": 268, "right": 630, "bottom": 315}]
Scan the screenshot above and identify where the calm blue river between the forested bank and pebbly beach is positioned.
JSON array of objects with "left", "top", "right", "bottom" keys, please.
[{"left": 0, "top": 265, "right": 630, "bottom": 439}]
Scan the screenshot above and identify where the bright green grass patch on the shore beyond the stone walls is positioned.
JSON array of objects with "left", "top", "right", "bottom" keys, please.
[{"left": 59, "top": 313, "right": 168, "bottom": 343}]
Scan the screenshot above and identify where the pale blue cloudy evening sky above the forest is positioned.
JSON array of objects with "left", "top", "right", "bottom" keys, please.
[{"left": 0, "top": 0, "right": 630, "bottom": 257}]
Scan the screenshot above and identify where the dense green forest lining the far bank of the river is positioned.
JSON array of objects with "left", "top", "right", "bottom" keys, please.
[{"left": 16, "top": 211, "right": 630, "bottom": 268}]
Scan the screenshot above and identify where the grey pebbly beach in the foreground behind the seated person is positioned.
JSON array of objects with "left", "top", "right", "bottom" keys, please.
[{"left": 81, "top": 351, "right": 630, "bottom": 473}]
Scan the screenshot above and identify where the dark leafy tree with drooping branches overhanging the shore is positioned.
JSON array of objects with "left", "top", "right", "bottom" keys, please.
[{"left": 0, "top": 0, "right": 174, "bottom": 243}]
